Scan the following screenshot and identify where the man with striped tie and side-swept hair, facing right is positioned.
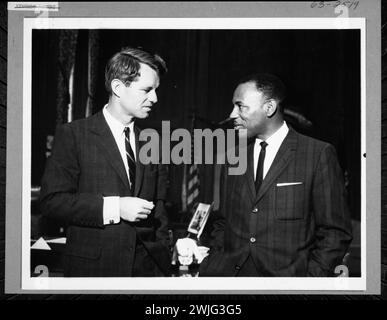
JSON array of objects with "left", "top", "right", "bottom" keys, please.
[{"left": 41, "top": 48, "right": 170, "bottom": 277}]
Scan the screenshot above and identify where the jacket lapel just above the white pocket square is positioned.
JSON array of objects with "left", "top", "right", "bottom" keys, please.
[{"left": 255, "top": 128, "right": 297, "bottom": 202}]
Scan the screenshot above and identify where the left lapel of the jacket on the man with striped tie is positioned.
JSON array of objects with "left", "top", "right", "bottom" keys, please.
[{"left": 90, "top": 111, "right": 129, "bottom": 189}]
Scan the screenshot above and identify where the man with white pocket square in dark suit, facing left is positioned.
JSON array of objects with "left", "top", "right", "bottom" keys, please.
[{"left": 178, "top": 74, "right": 352, "bottom": 277}]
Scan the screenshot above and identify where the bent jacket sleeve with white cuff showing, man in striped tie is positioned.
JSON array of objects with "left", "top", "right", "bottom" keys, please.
[{"left": 40, "top": 124, "right": 103, "bottom": 228}]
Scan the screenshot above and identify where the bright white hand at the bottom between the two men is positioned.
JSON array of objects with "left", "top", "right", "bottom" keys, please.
[{"left": 172, "top": 238, "right": 208, "bottom": 265}]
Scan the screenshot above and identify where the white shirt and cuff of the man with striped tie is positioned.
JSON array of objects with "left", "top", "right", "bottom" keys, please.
[{"left": 102, "top": 105, "right": 136, "bottom": 224}]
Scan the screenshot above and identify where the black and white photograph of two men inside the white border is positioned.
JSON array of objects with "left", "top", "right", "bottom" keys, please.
[{"left": 23, "top": 19, "right": 362, "bottom": 292}]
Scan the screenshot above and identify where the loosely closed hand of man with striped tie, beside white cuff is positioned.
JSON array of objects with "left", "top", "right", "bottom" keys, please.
[{"left": 120, "top": 197, "right": 154, "bottom": 222}]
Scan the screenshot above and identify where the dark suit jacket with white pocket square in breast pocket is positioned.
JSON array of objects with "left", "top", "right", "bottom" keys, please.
[{"left": 200, "top": 129, "right": 352, "bottom": 277}]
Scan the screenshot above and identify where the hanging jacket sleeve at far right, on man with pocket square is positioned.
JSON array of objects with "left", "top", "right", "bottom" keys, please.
[{"left": 308, "top": 145, "right": 352, "bottom": 277}]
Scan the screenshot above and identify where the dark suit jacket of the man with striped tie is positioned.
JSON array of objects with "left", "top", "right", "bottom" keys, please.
[{"left": 41, "top": 112, "right": 170, "bottom": 277}]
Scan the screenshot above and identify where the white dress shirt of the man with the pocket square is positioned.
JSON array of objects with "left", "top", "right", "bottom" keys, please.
[{"left": 254, "top": 121, "right": 289, "bottom": 181}]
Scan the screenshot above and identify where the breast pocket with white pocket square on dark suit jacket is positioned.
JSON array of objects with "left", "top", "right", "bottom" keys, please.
[{"left": 274, "top": 182, "right": 305, "bottom": 221}]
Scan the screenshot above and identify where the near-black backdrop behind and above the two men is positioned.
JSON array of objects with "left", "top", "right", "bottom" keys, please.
[{"left": 32, "top": 30, "right": 360, "bottom": 220}]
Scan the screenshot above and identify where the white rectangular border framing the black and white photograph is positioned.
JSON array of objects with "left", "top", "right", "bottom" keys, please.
[{"left": 21, "top": 17, "right": 367, "bottom": 294}]
